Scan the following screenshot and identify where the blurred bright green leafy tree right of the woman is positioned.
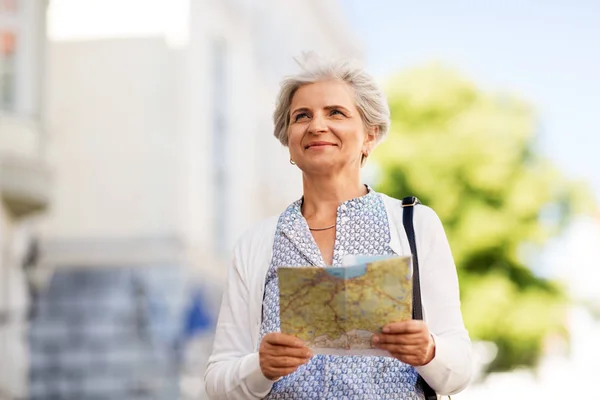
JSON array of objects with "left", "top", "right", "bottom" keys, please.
[{"left": 375, "top": 65, "right": 589, "bottom": 371}]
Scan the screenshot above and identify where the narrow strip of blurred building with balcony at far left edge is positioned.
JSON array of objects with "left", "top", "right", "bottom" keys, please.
[{"left": 0, "top": 0, "right": 51, "bottom": 399}]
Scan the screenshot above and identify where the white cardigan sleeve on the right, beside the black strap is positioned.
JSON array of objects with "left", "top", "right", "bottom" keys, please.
[{"left": 414, "top": 206, "right": 473, "bottom": 395}]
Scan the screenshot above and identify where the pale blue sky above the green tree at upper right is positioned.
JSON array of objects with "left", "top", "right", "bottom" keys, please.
[{"left": 340, "top": 0, "right": 600, "bottom": 202}]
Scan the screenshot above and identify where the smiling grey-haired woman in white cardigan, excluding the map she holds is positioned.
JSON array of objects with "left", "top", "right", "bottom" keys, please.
[{"left": 205, "top": 58, "right": 471, "bottom": 400}]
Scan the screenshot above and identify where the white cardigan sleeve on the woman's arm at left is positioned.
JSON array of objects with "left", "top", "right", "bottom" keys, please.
[{"left": 204, "top": 245, "right": 273, "bottom": 400}]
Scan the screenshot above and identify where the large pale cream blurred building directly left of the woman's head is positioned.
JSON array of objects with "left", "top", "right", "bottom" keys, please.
[{"left": 16, "top": 0, "right": 360, "bottom": 399}]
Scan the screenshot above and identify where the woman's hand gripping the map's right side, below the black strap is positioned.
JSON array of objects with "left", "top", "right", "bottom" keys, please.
[{"left": 373, "top": 320, "right": 435, "bottom": 367}]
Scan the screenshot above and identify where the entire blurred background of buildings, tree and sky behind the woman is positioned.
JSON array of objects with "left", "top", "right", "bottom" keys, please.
[{"left": 0, "top": 0, "right": 600, "bottom": 400}]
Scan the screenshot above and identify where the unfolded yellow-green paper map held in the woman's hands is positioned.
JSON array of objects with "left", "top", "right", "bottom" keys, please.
[{"left": 278, "top": 256, "right": 412, "bottom": 355}]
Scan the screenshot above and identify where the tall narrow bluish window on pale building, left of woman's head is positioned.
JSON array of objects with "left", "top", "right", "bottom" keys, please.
[{"left": 210, "top": 39, "right": 230, "bottom": 255}]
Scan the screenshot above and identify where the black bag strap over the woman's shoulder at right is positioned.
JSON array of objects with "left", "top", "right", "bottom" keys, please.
[{"left": 402, "top": 196, "right": 437, "bottom": 400}]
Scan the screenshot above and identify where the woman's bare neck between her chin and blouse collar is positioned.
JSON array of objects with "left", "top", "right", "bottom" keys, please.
[{"left": 302, "top": 171, "right": 367, "bottom": 223}]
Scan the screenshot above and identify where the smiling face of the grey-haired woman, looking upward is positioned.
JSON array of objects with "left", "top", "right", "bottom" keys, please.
[{"left": 288, "top": 80, "right": 374, "bottom": 173}]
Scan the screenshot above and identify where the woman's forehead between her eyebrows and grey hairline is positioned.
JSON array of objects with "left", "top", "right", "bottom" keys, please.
[{"left": 291, "top": 80, "right": 354, "bottom": 111}]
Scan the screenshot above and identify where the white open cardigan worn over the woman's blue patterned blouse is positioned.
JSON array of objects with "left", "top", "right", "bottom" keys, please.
[{"left": 204, "top": 195, "right": 472, "bottom": 400}]
